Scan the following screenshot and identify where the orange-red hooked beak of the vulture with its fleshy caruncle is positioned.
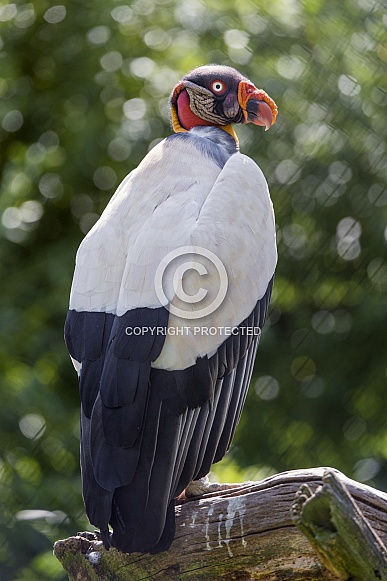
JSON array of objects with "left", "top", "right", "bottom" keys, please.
[{"left": 238, "top": 81, "right": 278, "bottom": 131}]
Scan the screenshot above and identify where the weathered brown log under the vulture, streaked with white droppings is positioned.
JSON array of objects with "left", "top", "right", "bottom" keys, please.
[{"left": 54, "top": 468, "right": 387, "bottom": 581}]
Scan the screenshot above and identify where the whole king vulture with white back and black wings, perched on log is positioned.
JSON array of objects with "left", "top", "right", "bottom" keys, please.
[{"left": 65, "top": 65, "right": 277, "bottom": 553}]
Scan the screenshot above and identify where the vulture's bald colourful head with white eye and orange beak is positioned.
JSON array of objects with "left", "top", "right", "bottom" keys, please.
[{"left": 170, "top": 65, "right": 278, "bottom": 132}]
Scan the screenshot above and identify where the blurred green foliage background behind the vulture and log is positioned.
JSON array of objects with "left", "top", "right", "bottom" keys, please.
[{"left": 0, "top": 0, "right": 387, "bottom": 581}]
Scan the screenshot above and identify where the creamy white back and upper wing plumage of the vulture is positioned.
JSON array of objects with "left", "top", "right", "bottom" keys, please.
[{"left": 70, "top": 129, "right": 277, "bottom": 370}]
